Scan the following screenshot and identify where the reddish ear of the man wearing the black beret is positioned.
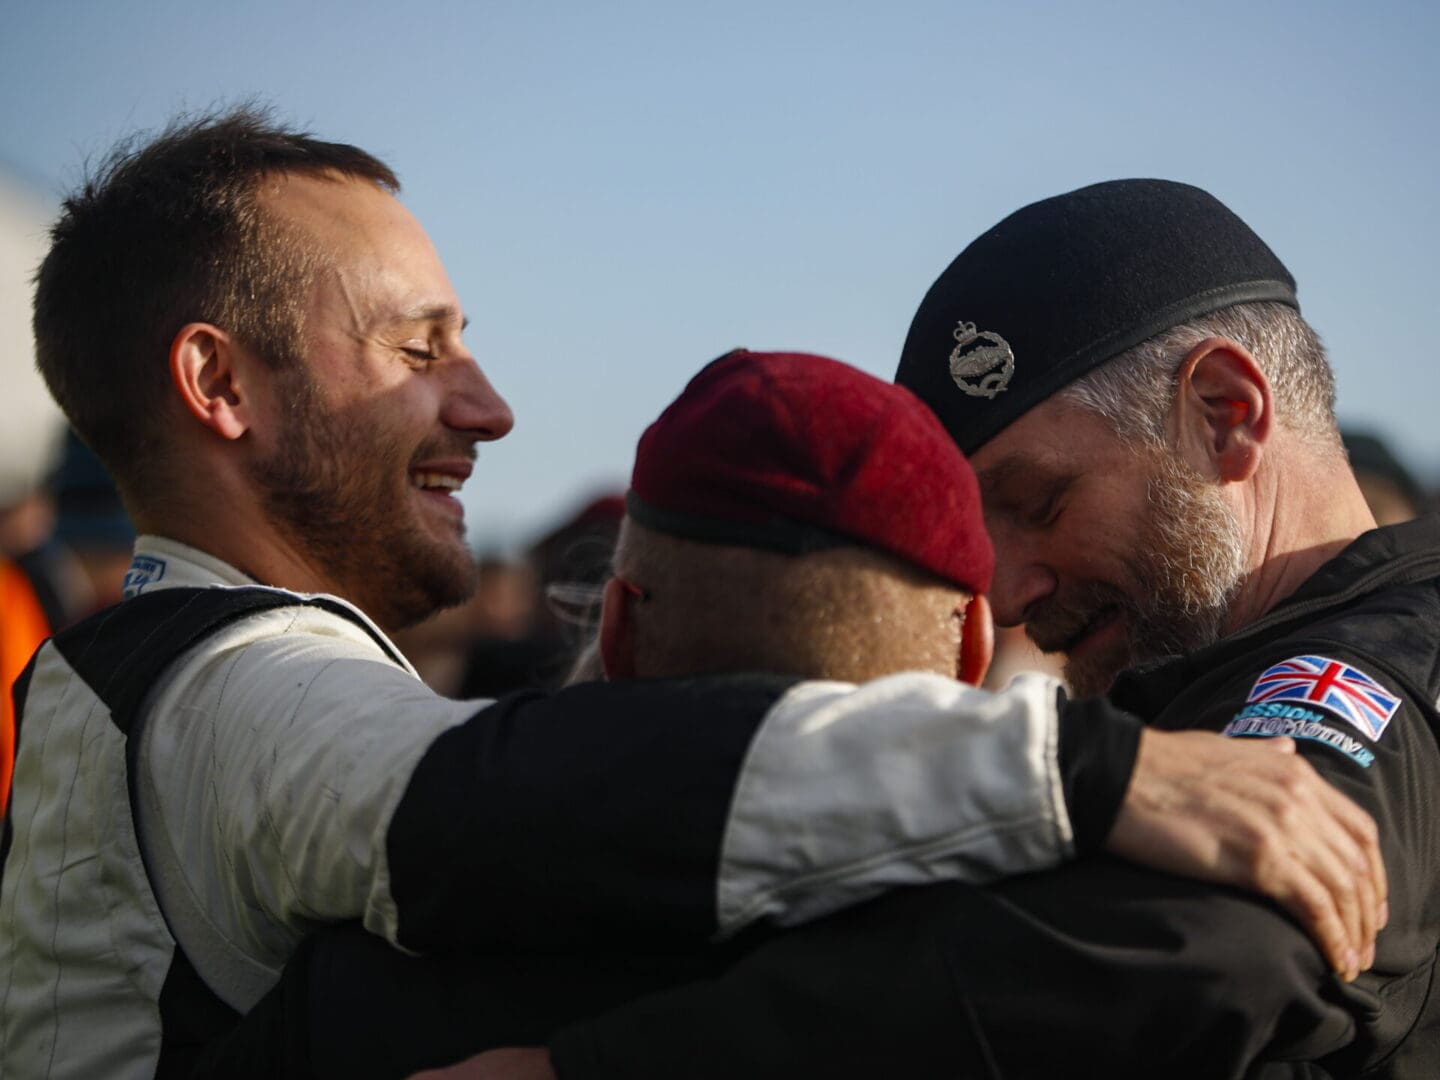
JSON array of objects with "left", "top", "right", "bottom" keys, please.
[{"left": 1171, "top": 337, "right": 1274, "bottom": 484}]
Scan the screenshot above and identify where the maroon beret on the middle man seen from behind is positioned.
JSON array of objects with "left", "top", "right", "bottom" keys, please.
[{"left": 626, "top": 350, "right": 995, "bottom": 592}]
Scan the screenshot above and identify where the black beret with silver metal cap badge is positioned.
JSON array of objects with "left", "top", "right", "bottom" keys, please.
[{"left": 896, "top": 180, "right": 1299, "bottom": 454}]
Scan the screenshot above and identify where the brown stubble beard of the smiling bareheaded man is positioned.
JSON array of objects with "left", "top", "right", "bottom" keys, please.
[{"left": 251, "top": 376, "right": 478, "bottom": 629}]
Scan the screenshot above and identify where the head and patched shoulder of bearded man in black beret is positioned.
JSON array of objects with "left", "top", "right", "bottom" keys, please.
[{"left": 897, "top": 180, "right": 1440, "bottom": 1076}]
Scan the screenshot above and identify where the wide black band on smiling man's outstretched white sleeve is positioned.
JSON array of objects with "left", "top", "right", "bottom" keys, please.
[{"left": 386, "top": 675, "right": 795, "bottom": 952}]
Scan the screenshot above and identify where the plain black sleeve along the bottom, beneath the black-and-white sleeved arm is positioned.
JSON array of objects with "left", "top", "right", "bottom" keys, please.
[{"left": 550, "top": 858, "right": 1375, "bottom": 1080}]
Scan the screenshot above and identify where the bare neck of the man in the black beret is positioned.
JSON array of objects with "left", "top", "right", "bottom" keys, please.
[{"left": 1225, "top": 444, "right": 1375, "bottom": 634}]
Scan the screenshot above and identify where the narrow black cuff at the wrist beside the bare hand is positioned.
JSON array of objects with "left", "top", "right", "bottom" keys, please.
[{"left": 1057, "top": 691, "right": 1143, "bottom": 854}]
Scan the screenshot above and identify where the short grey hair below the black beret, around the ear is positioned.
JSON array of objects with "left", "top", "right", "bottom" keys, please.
[{"left": 1058, "top": 302, "right": 1342, "bottom": 452}]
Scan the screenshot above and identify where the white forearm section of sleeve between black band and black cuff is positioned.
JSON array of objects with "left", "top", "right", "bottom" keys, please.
[{"left": 717, "top": 674, "right": 1074, "bottom": 935}]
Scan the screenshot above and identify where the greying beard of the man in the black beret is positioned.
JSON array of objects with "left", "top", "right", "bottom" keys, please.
[{"left": 1036, "top": 451, "right": 1246, "bottom": 697}]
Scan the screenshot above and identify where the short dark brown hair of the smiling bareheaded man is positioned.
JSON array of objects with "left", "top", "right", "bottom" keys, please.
[{"left": 35, "top": 105, "right": 399, "bottom": 497}]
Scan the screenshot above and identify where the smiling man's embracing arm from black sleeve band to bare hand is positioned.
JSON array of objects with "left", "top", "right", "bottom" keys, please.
[{"left": 387, "top": 674, "right": 1385, "bottom": 956}]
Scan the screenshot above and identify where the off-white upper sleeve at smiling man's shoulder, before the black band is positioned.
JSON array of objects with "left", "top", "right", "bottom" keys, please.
[{"left": 141, "top": 609, "right": 485, "bottom": 990}]
